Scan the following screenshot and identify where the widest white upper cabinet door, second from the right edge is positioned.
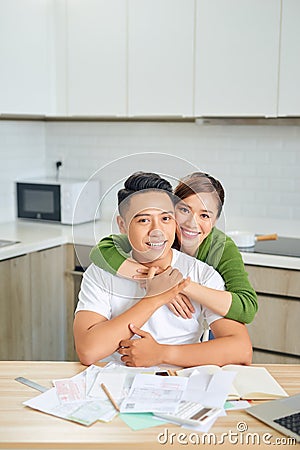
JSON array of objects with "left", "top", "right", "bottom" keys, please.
[{"left": 195, "top": 0, "right": 282, "bottom": 117}]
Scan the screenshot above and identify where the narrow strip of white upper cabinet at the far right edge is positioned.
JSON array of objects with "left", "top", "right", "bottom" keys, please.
[{"left": 278, "top": 0, "right": 300, "bottom": 116}]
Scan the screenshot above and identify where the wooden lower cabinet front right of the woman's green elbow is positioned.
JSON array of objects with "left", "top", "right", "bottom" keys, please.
[{"left": 246, "top": 265, "right": 300, "bottom": 364}]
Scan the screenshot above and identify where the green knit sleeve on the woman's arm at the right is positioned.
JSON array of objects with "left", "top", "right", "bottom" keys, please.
[{"left": 197, "top": 229, "right": 258, "bottom": 323}]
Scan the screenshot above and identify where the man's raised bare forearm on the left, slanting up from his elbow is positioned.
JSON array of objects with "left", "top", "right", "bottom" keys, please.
[{"left": 75, "top": 296, "right": 164, "bottom": 365}]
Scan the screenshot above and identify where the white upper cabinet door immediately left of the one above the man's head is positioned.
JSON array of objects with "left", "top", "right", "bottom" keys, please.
[{"left": 66, "top": 0, "right": 127, "bottom": 116}]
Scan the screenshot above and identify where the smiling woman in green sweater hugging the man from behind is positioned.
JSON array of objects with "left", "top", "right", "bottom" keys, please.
[{"left": 90, "top": 172, "right": 257, "bottom": 323}]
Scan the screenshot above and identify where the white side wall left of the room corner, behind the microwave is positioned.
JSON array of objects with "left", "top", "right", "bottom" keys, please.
[{"left": 0, "top": 120, "right": 46, "bottom": 223}]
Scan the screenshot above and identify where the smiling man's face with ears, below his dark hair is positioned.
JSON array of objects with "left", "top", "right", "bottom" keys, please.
[{"left": 118, "top": 191, "right": 176, "bottom": 263}]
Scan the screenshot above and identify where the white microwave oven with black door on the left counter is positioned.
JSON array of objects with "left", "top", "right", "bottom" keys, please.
[{"left": 16, "top": 178, "right": 100, "bottom": 225}]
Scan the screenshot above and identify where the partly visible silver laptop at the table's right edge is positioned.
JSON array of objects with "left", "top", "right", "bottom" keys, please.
[{"left": 246, "top": 394, "right": 300, "bottom": 442}]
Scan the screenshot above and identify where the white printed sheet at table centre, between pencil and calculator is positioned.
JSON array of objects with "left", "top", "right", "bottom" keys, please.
[{"left": 120, "top": 374, "right": 188, "bottom": 413}]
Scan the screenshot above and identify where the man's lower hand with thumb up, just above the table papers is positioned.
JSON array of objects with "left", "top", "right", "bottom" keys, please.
[{"left": 118, "top": 324, "right": 162, "bottom": 367}]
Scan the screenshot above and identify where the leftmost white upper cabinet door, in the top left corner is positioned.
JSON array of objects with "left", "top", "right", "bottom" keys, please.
[{"left": 0, "top": 0, "right": 55, "bottom": 115}]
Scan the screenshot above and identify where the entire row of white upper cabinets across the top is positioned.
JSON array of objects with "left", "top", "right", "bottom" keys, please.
[{"left": 0, "top": 0, "right": 300, "bottom": 118}]
